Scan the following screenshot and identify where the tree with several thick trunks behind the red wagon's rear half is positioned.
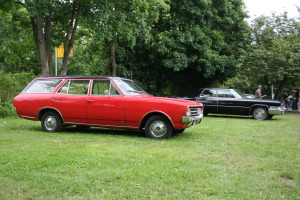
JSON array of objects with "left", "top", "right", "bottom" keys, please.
[{"left": 2, "top": 0, "right": 99, "bottom": 76}]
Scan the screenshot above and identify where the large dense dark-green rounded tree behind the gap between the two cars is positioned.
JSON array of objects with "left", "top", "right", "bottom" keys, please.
[{"left": 119, "top": 0, "right": 249, "bottom": 95}]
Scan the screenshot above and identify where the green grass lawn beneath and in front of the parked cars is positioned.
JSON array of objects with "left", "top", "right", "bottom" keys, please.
[{"left": 0, "top": 113, "right": 300, "bottom": 200}]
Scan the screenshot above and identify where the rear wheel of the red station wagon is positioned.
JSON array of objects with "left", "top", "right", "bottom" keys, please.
[{"left": 41, "top": 111, "right": 63, "bottom": 132}]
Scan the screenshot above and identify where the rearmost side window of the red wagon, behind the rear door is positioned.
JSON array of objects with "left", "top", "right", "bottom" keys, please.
[{"left": 24, "top": 79, "right": 62, "bottom": 93}]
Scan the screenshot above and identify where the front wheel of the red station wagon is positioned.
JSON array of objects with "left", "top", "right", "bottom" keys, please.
[{"left": 145, "top": 115, "right": 173, "bottom": 139}]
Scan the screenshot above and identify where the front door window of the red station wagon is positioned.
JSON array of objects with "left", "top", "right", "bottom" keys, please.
[{"left": 92, "top": 80, "right": 120, "bottom": 96}]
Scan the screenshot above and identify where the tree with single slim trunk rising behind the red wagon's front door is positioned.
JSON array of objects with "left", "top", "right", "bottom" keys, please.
[{"left": 92, "top": 0, "right": 169, "bottom": 76}]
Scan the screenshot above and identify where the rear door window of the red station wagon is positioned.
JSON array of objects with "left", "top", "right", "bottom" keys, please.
[{"left": 58, "top": 80, "right": 90, "bottom": 94}]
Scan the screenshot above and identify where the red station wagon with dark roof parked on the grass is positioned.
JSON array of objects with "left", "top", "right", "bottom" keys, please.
[{"left": 14, "top": 76, "right": 203, "bottom": 139}]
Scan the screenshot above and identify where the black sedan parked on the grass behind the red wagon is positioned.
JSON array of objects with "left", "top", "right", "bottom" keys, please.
[{"left": 180, "top": 88, "right": 284, "bottom": 120}]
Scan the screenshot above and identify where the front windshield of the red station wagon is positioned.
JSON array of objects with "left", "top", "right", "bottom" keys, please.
[{"left": 114, "top": 79, "right": 149, "bottom": 95}]
